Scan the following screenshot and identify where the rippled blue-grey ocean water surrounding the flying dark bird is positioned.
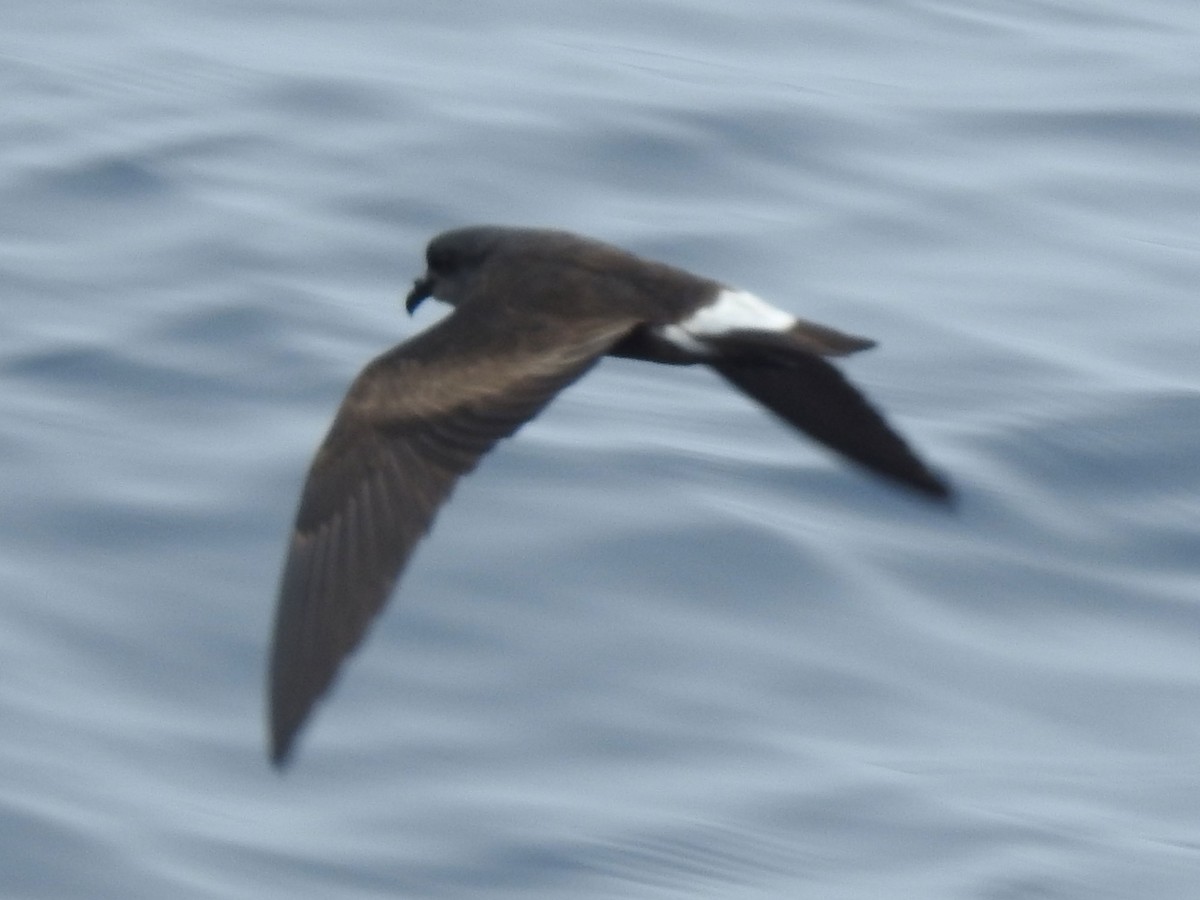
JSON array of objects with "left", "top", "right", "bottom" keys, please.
[{"left": 0, "top": 0, "right": 1200, "bottom": 900}]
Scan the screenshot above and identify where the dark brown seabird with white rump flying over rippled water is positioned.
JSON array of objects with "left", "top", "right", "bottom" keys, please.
[{"left": 269, "top": 226, "right": 950, "bottom": 766}]
